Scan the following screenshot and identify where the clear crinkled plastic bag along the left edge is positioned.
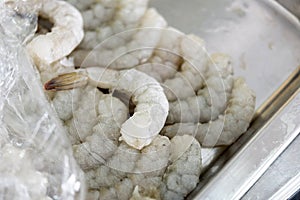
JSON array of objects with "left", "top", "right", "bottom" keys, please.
[{"left": 0, "top": 0, "right": 84, "bottom": 200}]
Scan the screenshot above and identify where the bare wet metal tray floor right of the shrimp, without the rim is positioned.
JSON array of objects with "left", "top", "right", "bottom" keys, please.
[{"left": 151, "top": 0, "right": 300, "bottom": 107}]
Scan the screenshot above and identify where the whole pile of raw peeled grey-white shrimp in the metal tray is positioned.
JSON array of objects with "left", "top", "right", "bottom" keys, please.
[{"left": 27, "top": 0, "right": 255, "bottom": 199}]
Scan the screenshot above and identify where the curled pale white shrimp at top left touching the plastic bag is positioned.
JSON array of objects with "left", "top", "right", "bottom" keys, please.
[{"left": 27, "top": 0, "right": 83, "bottom": 66}]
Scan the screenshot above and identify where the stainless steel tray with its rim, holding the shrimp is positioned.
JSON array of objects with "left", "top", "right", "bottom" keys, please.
[{"left": 151, "top": 0, "right": 300, "bottom": 199}]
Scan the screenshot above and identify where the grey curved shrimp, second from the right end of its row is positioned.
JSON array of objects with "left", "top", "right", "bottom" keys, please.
[{"left": 167, "top": 53, "right": 233, "bottom": 124}]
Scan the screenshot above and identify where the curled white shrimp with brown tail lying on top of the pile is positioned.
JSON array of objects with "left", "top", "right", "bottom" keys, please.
[{"left": 45, "top": 67, "right": 169, "bottom": 149}]
